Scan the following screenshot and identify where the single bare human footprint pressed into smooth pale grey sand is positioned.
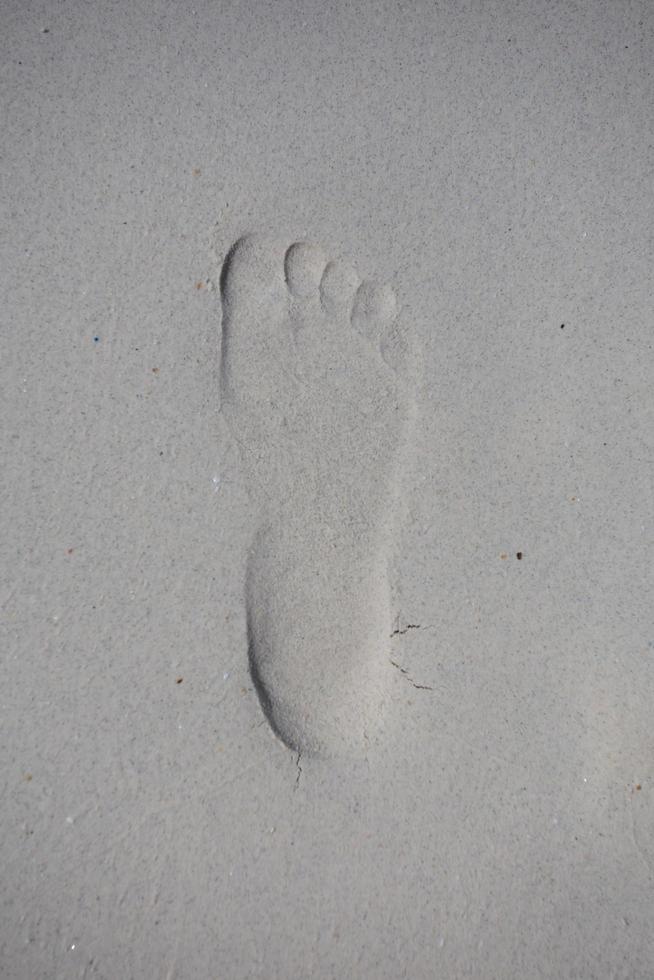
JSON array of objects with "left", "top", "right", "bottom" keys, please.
[{"left": 221, "top": 237, "right": 413, "bottom": 754}]
